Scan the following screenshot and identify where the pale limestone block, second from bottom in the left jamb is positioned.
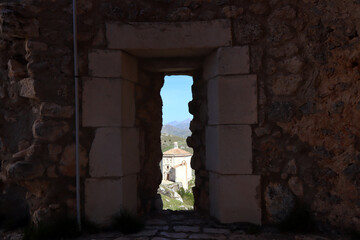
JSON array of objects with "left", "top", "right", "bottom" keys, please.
[{"left": 89, "top": 128, "right": 140, "bottom": 177}]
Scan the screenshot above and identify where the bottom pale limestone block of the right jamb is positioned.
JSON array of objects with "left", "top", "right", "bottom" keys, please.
[{"left": 209, "top": 173, "right": 261, "bottom": 225}]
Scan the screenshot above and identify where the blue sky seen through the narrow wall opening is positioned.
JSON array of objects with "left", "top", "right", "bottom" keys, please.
[{"left": 160, "top": 75, "right": 193, "bottom": 125}]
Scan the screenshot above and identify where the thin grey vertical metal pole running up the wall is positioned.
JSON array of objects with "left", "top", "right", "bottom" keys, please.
[{"left": 73, "top": 0, "right": 81, "bottom": 231}]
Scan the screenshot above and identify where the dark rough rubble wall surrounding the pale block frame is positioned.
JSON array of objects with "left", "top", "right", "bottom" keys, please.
[{"left": 0, "top": 0, "right": 360, "bottom": 231}]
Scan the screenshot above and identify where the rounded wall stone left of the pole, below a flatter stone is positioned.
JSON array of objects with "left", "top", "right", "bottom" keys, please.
[{"left": 33, "top": 119, "right": 70, "bottom": 142}]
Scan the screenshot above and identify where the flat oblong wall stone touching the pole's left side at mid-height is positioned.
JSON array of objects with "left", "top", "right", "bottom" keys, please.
[{"left": 40, "top": 102, "right": 74, "bottom": 118}]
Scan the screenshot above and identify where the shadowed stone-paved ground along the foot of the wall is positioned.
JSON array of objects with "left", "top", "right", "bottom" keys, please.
[{"left": 0, "top": 211, "right": 357, "bottom": 240}]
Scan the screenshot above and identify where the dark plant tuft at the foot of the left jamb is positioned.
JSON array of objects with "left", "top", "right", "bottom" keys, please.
[{"left": 111, "top": 210, "right": 145, "bottom": 234}]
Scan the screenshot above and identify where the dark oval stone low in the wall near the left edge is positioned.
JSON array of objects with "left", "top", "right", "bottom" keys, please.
[{"left": 7, "top": 162, "right": 44, "bottom": 180}]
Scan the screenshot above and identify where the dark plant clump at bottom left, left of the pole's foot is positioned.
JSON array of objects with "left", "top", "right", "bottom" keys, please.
[{"left": 23, "top": 216, "right": 80, "bottom": 240}]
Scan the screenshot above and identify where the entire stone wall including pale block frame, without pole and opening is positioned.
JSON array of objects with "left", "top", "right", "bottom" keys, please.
[{"left": 0, "top": 0, "right": 360, "bottom": 231}]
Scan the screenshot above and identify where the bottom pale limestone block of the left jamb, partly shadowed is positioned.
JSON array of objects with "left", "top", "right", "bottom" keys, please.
[{"left": 85, "top": 175, "right": 137, "bottom": 226}]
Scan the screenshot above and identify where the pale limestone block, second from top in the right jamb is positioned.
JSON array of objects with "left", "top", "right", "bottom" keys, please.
[{"left": 208, "top": 75, "right": 257, "bottom": 125}]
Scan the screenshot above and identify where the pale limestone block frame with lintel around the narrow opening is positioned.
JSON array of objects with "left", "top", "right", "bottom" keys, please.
[{"left": 82, "top": 20, "right": 261, "bottom": 224}]
